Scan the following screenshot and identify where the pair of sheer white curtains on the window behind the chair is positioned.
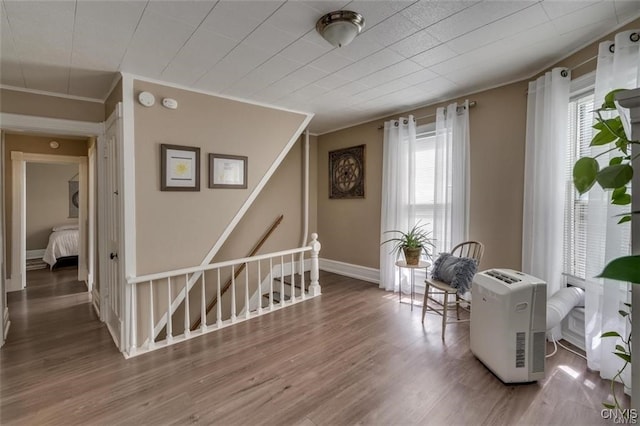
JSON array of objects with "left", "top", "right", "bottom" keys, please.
[{"left": 380, "top": 101, "right": 470, "bottom": 291}]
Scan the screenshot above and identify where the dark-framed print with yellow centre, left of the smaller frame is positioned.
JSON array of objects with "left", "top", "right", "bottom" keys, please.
[{"left": 160, "top": 144, "right": 200, "bottom": 191}]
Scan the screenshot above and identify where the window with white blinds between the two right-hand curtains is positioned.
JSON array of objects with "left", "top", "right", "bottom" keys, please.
[{"left": 563, "top": 89, "right": 594, "bottom": 284}]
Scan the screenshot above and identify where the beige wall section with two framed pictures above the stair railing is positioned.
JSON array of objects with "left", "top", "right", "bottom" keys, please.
[{"left": 134, "top": 81, "right": 306, "bottom": 275}]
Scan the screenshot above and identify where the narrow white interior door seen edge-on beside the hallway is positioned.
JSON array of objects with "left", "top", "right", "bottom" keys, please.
[{"left": 98, "top": 108, "right": 125, "bottom": 349}]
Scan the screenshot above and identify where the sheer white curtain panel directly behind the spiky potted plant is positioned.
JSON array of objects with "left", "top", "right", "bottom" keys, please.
[{"left": 380, "top": 115, "right": 416, "bottom": 291}]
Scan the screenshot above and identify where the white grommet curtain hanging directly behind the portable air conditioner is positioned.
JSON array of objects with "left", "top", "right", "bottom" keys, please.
[{"left": 522, "top": 68, "right": 571, "bottom": 339}]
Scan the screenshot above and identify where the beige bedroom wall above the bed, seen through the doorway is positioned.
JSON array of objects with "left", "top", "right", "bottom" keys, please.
[{"left": 26, "top": 163, "right": 78, "bottom": 250}]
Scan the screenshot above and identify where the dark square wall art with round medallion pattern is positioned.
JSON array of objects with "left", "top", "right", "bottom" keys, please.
[{"left": 329, "top": 145, "right": 365, "bottom": 199}]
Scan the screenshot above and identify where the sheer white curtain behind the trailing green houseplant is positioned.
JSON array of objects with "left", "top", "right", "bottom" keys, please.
[{"left": 585, "top": 30, "right": 640, "bottom": 386}]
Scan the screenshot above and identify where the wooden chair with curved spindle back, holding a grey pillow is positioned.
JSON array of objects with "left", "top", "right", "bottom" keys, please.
[{"left": 422, "top": 241, "right": 484, "bottom": 340}]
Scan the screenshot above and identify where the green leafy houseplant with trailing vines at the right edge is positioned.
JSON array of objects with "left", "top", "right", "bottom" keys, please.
[{"left": 573, "top": 89, "right": 640, "bottom": 409}]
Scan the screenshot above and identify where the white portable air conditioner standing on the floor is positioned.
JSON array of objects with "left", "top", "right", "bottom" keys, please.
[{"left": 470, "top": 269, "right": 547, "bottom": 383}]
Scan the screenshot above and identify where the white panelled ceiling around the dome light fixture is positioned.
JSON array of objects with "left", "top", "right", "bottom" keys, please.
[{"left": 0, "top": 0, "right": 640, "bottom": 133}]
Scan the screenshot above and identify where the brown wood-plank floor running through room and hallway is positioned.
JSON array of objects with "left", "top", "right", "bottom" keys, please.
[{"left": 0, "top": 270, "right": 620, "bottom": 425}]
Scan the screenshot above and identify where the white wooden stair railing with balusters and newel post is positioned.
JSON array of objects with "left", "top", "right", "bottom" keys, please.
[{"left": 125, "top": 233, "right": 321, "bottom": 357}]
